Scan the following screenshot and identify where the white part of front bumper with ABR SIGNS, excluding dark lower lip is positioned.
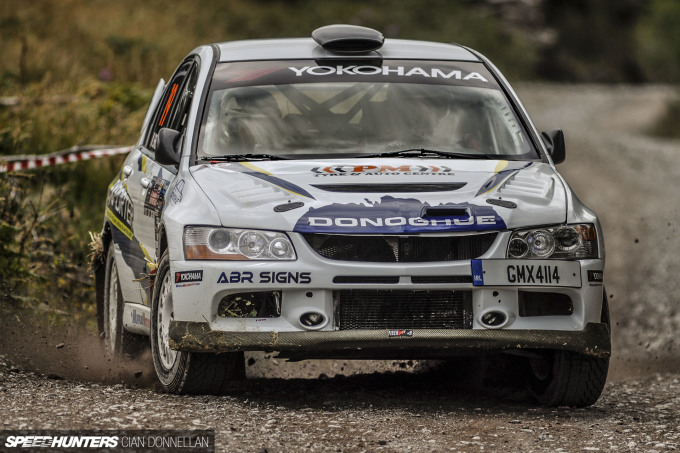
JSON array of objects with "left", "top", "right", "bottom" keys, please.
[{"left": 171, "top": 254, "right": 604, "bottom": 335}]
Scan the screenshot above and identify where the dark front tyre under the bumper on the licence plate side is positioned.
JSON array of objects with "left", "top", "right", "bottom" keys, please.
[{"left": 529, "top": 292, "right": 609, "bottom": 407}]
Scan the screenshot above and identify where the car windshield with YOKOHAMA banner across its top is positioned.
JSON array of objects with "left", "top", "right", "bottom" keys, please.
[{"left": 197, "top": 61, "right": 538, "bottom": 160}]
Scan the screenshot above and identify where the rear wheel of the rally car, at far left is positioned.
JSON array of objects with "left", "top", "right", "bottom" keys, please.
[{"left": 99, "top": 242, "right": 145, "bottom": 358}]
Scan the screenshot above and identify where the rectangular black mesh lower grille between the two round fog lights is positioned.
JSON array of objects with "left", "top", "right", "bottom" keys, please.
[{"left": 333, "top": 290, "right": 472, "bottom": 330}]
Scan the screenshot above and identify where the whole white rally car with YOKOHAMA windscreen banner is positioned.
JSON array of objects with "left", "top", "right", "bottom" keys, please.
[{"left": 96, "top": 25, "right": 611, "bottom": 406}]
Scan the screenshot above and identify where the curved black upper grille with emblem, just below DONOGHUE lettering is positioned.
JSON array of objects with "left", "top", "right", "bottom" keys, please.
[{"left": 302, "top": 233, "right": 497, "bottom": 263}]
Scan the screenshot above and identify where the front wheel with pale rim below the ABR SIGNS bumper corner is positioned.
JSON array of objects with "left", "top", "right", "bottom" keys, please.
[{"left": 151, "top": 251, "right": 245, "bottom": 394}]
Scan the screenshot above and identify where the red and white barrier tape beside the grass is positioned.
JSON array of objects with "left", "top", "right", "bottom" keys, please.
[{"left": 0, "top": 146, "right": 133, "bottom": 173}]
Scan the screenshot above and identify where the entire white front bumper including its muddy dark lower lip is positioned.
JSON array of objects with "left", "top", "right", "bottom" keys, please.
[{"left": 169, "top": 228, "right": 611, "bottom": 359}]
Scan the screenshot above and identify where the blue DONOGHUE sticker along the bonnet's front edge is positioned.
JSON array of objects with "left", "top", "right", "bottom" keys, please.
[{"left": 294, "top": 196, "right": 505, "bottom": 233}]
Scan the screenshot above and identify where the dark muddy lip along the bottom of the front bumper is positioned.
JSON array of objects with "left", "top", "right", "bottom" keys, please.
[{"left": 170, "top": 321, "right": 611, "bottom": 359}]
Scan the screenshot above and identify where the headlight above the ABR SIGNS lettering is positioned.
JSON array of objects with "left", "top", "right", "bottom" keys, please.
[{"left": 184, "top": 227, "right": 297, "bottom": 261}]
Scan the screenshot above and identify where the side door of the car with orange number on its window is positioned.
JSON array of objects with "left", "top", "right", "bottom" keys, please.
[{"left": 126, "top": 58, "right": 198, "bottom": 304}]
